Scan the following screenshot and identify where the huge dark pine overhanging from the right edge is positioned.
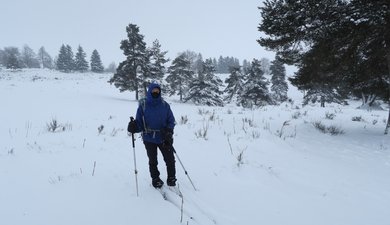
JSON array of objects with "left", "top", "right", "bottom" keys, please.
[{"left": 258, "top": 0, "right": 390, "bottom": 133}]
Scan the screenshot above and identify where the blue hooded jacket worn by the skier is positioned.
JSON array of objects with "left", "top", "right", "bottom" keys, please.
[{"left": 135, "top": 83, "right": 175, "bottom": 144}]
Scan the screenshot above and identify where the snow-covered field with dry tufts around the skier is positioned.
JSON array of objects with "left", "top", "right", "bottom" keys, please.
[{"left": 0, "top": 70, "right": 390, "bottom": 225}]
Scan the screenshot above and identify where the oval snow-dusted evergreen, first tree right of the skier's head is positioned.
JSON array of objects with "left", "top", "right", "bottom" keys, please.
[{"left": 166, "top": 53, "right": 194, "bottom": 101}]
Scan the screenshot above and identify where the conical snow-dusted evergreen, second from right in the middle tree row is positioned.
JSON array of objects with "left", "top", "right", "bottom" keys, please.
[{"left": 237, "top": 59, "right": 272, "bottom": 108}]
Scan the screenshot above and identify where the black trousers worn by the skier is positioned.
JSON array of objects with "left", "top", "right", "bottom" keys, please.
[{"left": 144, "top": 141, "right": 176, "bottom": 179}]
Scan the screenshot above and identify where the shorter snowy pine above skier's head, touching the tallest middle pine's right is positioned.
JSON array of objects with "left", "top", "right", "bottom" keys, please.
[{"left": 147, "top": 39, "right": 169, "bottom": 83}]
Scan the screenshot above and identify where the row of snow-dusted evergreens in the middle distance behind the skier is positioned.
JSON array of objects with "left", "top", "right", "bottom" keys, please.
[{"left": 108, "top": 24, "right": 288, "bottom": 108}]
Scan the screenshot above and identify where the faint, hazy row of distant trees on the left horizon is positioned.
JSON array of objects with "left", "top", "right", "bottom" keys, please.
[{"left": 0, "top": 44, "right": 116, "bottom": 73}]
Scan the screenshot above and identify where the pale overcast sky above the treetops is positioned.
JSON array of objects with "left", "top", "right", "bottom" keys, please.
[{"left": 0, "top": 0, "right": 274, "bottom": 66}]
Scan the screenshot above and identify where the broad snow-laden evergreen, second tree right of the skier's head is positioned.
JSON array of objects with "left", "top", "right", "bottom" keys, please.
[{"left": 184, "top": 59, "right": 224, "bottom": 106}]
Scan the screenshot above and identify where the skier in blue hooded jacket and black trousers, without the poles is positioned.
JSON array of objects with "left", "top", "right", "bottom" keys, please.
[{"left": 127, "top": 83, "right": 176, "bottom": 188}]
